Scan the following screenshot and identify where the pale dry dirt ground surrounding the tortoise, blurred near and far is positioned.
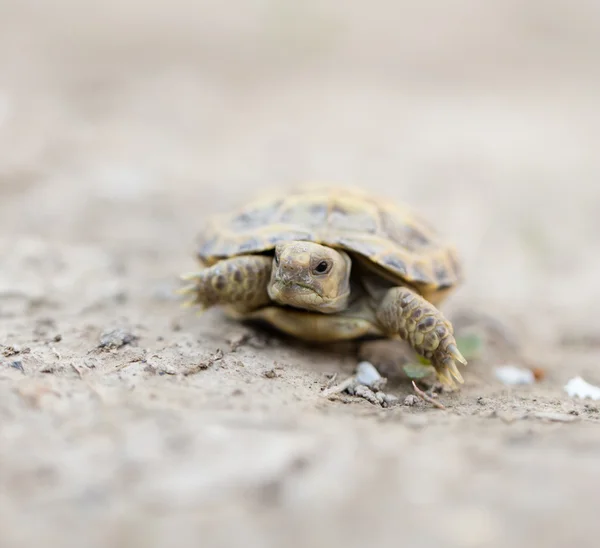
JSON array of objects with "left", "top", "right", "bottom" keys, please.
[{"left": 0, "top": 0, "right": 600, "bottom": 548}]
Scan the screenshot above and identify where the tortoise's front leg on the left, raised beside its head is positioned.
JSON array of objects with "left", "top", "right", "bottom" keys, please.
[{"left": 181, "top": 255, "right": 273, "bottom": 310}]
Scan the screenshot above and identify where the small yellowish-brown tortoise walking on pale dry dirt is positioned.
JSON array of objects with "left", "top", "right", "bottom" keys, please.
[{"left": 182, "top": 185, "right": 467, "bottom": 386}]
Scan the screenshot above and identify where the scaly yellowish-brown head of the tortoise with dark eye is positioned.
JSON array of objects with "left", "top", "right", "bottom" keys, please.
[{"left": 268, "top": 242, "right": 352, "bottom": 314}]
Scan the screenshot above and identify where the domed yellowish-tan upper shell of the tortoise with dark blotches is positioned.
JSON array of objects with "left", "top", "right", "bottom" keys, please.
[{"left": 198, "top": 186, "right": 462, "bottom": 298}]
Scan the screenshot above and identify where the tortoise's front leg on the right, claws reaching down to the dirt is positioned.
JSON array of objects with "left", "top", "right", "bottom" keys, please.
[{"left": 377, "top": 287, "right": 467, "bottom": 386}]
